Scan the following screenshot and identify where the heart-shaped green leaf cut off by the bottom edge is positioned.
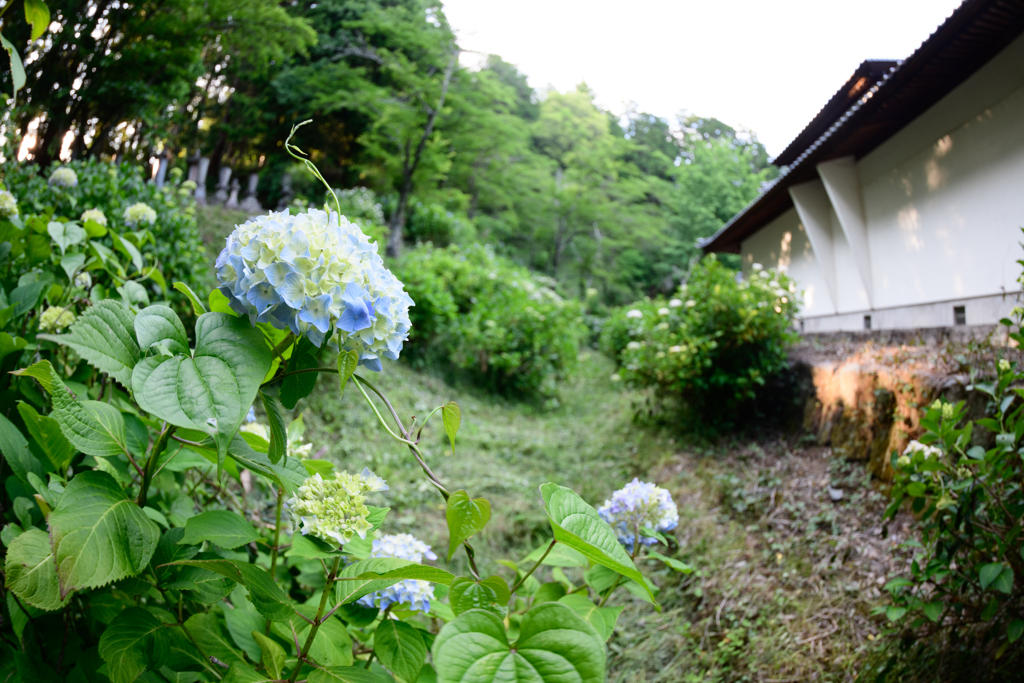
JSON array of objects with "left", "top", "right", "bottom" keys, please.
[{"left": 432, "top": 602, "right": 605, "bottom": 683}]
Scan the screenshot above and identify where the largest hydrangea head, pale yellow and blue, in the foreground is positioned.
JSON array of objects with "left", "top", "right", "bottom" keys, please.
[{"left": 216, "top": 209, "right": 413, "bottom": 362}]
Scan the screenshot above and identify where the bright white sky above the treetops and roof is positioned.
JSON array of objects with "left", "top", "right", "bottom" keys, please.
[{"left": 444, "top": 0, "right": 961, "bottom": 156}]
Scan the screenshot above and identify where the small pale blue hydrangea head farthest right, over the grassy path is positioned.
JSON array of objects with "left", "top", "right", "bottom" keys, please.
[{"left": 597, "top": 478, "right": 679, "bottom": 553}]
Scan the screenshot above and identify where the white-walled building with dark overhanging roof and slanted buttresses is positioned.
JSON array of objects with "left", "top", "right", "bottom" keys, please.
[{"left": 701, "top": 0, "right": 1024, "bottom": 333}]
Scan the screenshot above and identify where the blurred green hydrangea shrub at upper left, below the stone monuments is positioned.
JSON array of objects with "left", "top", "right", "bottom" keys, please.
[{"left": 0, "top": 159, "right": 212, "bottom": 303}]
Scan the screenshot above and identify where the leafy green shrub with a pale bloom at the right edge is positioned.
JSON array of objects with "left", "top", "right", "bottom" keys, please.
[{"left": 879, "top": 344, "right": 1024, "bottom": 680}]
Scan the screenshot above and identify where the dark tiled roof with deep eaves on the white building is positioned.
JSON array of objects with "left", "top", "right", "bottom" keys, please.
[{"left": 700, "top": 0, "right": 1024, "bottom": 253}]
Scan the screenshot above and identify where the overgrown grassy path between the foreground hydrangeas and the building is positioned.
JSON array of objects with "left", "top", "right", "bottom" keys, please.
[{"left": 284, "top": 352, "right": 909, "bottom": 683}]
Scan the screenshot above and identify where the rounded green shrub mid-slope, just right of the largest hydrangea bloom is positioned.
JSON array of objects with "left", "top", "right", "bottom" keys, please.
[{"left": 396, "top": 245, "right": 587, "bottom": 396}]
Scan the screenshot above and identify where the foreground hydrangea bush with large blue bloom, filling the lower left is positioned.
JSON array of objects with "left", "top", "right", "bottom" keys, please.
[{"left": 0, "top": 127, "right": 671, "bottom": 683}]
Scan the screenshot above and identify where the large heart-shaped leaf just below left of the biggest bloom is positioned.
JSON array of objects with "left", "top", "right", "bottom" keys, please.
[{"left": 131, "top": 313, "right": 271, "bottom": 473}]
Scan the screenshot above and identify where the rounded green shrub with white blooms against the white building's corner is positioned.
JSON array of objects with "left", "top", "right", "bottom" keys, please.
[{"left": 601, "top": 256, "right": 799, "bottom": 419}]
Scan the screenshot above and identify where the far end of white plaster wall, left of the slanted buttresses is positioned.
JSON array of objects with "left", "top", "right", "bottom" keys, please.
[{"left": 741, "top": 209, "right": 836, "bottom": 315}]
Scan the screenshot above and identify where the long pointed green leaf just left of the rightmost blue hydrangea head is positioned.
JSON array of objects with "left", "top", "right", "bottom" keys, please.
[{"left": 541, "top": 483, "right": 657, "bottom": 608}]
